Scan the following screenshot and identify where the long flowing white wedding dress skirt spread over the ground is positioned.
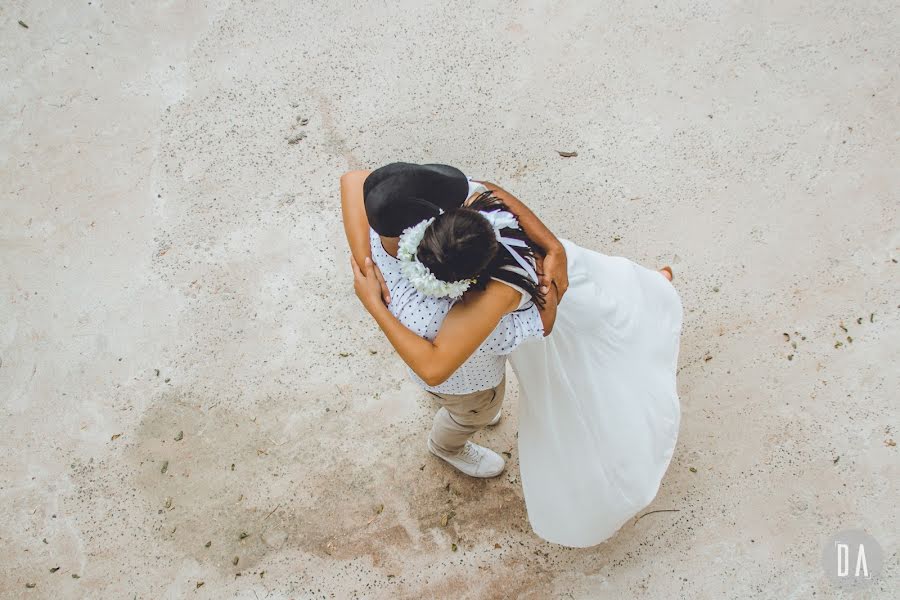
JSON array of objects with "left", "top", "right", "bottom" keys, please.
[{"left": 510, "top": 240, "right": 682, "bottom": 547}]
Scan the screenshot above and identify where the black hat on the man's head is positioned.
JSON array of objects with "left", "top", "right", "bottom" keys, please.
[{"left": 363, "top": 163, "right": 469, "bottom": 237}]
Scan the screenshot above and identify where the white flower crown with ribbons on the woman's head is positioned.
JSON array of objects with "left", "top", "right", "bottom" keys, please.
[{"left": 397, "top": 210, "right": 538, "bottom": 300}]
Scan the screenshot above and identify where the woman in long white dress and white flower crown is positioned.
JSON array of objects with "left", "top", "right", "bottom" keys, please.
[{"left": 351, "top": 169, "right": 682, "bottom": 547}]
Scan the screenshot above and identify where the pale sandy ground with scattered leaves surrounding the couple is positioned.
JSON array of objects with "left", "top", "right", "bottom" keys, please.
[{"left": 0, "top": 0, "right": 900, "bottom": 600}]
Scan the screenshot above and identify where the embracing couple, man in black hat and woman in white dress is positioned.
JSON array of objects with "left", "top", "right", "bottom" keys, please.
[{"left": 341, "top": 163, "right": 682, "bottom": 547}]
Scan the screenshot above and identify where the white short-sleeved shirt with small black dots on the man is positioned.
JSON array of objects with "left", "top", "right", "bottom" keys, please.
[{"left": 369, "top": 224, "right": 544, "bottom": 394}]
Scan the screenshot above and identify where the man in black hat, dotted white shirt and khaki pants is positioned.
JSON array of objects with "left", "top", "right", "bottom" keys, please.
[{"left": 341, "top": 163, "right": 568, "bottom": 477}]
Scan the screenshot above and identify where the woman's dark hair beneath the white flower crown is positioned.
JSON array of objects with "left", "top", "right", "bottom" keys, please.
[{"left": 416, "top": 192, "right": 544, "bottom": 307}]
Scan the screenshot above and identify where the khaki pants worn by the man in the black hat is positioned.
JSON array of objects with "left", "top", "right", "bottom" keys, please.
[{"left": 429, "top": 375, "right": 506, "bottom": 454}]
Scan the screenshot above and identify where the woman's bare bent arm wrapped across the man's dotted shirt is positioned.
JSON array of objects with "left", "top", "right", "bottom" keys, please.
[{"left": 351, "top": 258, "right": 521, "bottom": 386}]
